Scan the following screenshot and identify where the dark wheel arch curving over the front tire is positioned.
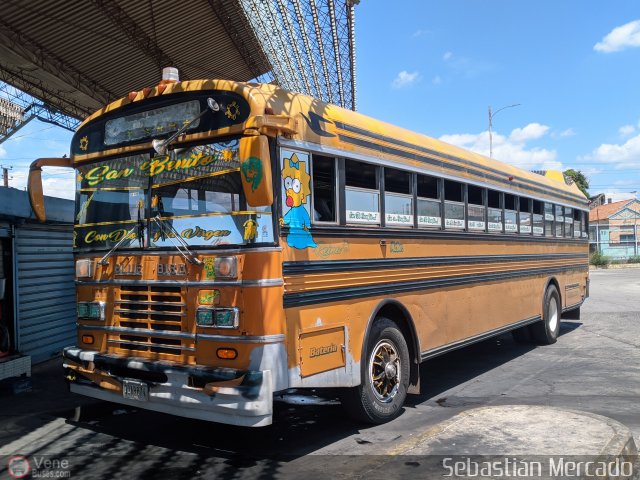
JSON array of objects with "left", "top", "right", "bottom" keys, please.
[{"left": 362, "top": 299, "right": 420, "bottom": 393}]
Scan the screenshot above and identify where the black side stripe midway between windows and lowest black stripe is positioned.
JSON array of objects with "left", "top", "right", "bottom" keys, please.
[{"left": 282, "top": 253, "right": 589, "bottom": 276}]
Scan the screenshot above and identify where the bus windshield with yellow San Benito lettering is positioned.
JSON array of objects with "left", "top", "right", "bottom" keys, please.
[{"left": 74, "top": 139, "right": 274, "bottom": 251}]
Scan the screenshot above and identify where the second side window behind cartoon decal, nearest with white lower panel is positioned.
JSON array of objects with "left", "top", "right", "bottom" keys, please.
[{"left": 344, "top": 160, "right": 380, "bottom": 225}]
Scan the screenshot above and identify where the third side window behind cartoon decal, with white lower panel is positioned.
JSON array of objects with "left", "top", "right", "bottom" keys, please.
[{"left": 384, "top": 168, "right": 413, "bottom": 227}]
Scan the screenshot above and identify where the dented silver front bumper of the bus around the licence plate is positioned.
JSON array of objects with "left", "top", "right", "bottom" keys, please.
[{"left": 63, "top": 347, "right": 273, "bottom": 427}]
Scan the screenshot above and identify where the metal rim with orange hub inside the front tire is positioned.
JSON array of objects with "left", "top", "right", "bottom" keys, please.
[{"left": 369, "top": 340, "right": 401, "bottom": 403}]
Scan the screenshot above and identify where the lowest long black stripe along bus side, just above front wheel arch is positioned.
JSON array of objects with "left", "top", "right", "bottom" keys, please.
[{"left": 284, "top": 265, "right": 588, "bottom": 308}]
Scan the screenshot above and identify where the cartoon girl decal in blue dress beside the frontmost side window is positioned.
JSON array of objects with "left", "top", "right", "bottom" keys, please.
[{"left": 280, "top": 150, "right": 317, "bottom": 249}]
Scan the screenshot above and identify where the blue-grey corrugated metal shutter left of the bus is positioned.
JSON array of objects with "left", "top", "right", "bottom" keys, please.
[{"left": 14, "top": 224, "right": 76, "bottom": 362}]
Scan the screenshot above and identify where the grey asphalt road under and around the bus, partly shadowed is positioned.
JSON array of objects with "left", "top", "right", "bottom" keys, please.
[{"left": 0, "top": 269, "right": 640, "bottom": 479}]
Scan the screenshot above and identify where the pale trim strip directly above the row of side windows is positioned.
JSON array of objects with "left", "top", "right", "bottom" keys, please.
[{"left": 278, "top": 137, "right": 586, "bottom": 211}]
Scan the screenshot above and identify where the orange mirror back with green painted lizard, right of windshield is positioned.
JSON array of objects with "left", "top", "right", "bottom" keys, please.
[{"left": 239, "top": 135, "right": 273, "bottom": 207}]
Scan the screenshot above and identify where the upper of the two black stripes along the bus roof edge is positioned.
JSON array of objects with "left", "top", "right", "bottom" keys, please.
[{"left": 335, "top": 122, "right": 586, "bottom": 203}]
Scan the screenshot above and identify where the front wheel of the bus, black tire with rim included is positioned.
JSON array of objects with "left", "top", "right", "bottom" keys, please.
[{"left": 342, "top": 317, "right": 410, "bottom": 424}]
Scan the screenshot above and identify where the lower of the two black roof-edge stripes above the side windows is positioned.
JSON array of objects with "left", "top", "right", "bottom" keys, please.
[{"left": 338, "top": 134, "right": 587, "bottom": 208}]
